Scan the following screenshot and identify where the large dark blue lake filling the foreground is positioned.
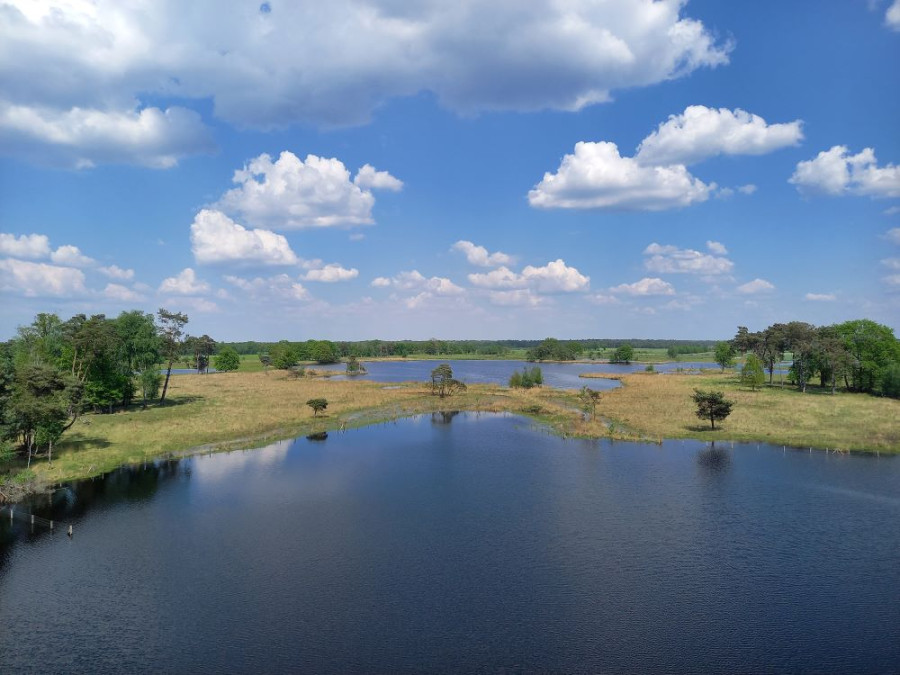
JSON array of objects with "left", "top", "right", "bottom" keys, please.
[{"left": 0, "top": 414, "right": 900, "bottom": 673}]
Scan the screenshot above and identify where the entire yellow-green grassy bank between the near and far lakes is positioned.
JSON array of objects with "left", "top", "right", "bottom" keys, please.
[{"left": 5, "top": 371, "right": 900, "bottom": 500}]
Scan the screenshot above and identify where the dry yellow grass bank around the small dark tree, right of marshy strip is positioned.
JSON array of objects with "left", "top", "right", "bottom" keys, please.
[{"left": 585, "top": 371, "right": 900, "bottom": 453}]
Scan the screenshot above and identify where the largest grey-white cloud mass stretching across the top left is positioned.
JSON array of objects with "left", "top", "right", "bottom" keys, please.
[{"left": 0, "top": 0, "right": 731, "bottom": 147}]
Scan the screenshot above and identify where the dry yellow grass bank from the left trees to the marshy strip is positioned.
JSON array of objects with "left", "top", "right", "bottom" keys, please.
[{"left": 32, "top": 371, "right": 576, "bottom": 482}]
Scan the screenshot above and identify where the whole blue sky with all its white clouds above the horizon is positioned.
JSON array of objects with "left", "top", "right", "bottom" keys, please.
[{"left": 0, "top": 0, "right": 900, "bottom": 341}]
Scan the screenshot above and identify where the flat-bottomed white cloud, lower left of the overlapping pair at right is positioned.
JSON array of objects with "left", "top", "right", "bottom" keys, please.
[{"left": 528, "top": 141, "right": 715, "bottom": 211}]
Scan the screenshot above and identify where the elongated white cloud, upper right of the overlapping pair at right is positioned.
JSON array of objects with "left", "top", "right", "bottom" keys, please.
[{"left": 635, "top": 105, "right": 803, "bottom": 166}]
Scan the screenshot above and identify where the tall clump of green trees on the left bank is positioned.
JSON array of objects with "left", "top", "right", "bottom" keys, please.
[{"left": 0, "top": 309, "right": 240, "bottom": 466}]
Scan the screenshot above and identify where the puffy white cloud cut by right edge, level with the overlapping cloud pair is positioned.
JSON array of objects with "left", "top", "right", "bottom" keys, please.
[{"left": 789, "top": 145, "right": 900, "bottom": 198}]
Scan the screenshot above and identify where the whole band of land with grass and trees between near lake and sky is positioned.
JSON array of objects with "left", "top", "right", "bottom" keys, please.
[{"left": 0, "top": 309, "right": 900, "bottom": 499}]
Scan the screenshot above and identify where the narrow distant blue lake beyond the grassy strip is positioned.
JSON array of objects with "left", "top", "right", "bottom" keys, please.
[{"left": 312, "top": 359, "right": 716, "bottom": 390}]
